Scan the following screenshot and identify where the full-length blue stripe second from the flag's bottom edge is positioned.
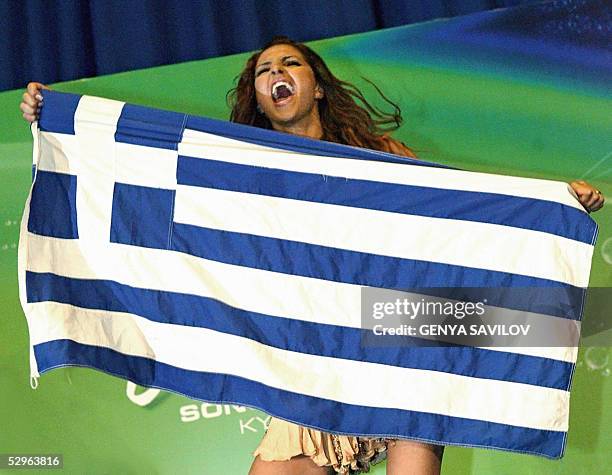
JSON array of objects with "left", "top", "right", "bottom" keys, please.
[{"left": 26, "top": 272, "right": 573, "bottom": 390}]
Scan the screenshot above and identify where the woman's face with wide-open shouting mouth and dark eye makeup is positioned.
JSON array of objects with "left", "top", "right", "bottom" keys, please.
[{"left": 255, "top": 44, "right": 323, "bottom": 133}]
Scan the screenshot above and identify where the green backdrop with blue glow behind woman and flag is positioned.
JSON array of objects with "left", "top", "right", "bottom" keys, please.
[{"left": 0, "top": 12, "right": 612, "bottom": 474}]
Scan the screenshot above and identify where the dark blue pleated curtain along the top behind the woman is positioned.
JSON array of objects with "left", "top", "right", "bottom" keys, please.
[{"left": 0, "top": 0, "right": 534, "bottom": 90}]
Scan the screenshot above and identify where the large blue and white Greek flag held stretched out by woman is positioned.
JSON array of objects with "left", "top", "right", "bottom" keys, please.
[{"left": 19, "top": 91, "right": 597, "bottom": 458}]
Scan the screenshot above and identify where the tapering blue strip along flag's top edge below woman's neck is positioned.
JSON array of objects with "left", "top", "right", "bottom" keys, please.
[{"left": 185, "top": 116, "right": 452, "bottom": 168}]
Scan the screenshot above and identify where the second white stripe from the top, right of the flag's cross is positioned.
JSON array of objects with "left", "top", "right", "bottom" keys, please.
[{"left": 174, "top": 185, "right": 593, "bottom": 287}]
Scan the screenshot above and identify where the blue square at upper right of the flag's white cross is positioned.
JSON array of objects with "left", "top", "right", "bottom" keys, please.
[{"left": 115, "top": 104, "right": 186, "bottom": 150}]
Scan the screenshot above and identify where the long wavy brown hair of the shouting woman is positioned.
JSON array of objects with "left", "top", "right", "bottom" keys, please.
[{"left": 227, "top": 36, "right": 402, "bottom": 150}]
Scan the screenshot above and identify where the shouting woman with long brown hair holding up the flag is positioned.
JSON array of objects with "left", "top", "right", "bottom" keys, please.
[{"left": 20, "top": 38, "right": 604, "bottom": 475}]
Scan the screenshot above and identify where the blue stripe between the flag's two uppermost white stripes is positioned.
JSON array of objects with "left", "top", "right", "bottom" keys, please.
[{"left": 177, "top": 156, "right": 595, "bottom": 244}]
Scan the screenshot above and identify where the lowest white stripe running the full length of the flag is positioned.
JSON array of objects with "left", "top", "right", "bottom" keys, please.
[{"left": 31, "top": 303, "right": 569, "bottom": 431}]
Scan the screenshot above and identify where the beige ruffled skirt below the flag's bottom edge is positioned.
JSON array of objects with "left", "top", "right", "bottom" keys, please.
[{"left": 253, "top": 417, "right": 393, "bottom": 475}]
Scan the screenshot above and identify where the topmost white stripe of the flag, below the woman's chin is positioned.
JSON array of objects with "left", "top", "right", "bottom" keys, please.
[{"left": 178, "top": 129, "right": 584, "bottom": 212}]
